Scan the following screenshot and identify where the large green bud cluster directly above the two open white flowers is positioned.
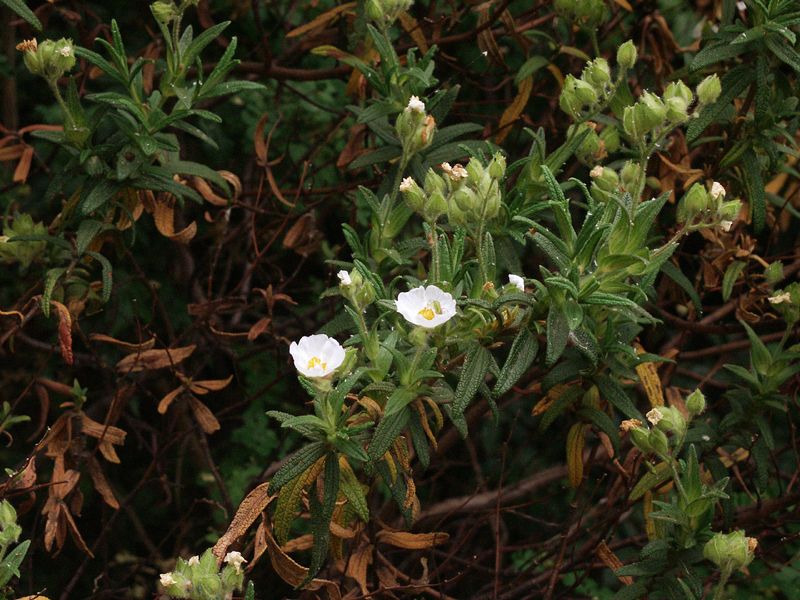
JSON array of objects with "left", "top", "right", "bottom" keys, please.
[{"left": 400, "top": 152, "right": 506, "bottom": 225}]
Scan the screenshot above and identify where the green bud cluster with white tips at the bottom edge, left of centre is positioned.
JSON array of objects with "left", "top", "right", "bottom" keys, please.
[{"left": 160, "top": 548, "right": 242, "bottom": 600}]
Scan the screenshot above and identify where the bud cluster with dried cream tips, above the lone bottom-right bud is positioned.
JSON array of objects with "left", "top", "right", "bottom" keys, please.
[{"left": 620, "top": 390, "right": 706, "bottom": 457}]
